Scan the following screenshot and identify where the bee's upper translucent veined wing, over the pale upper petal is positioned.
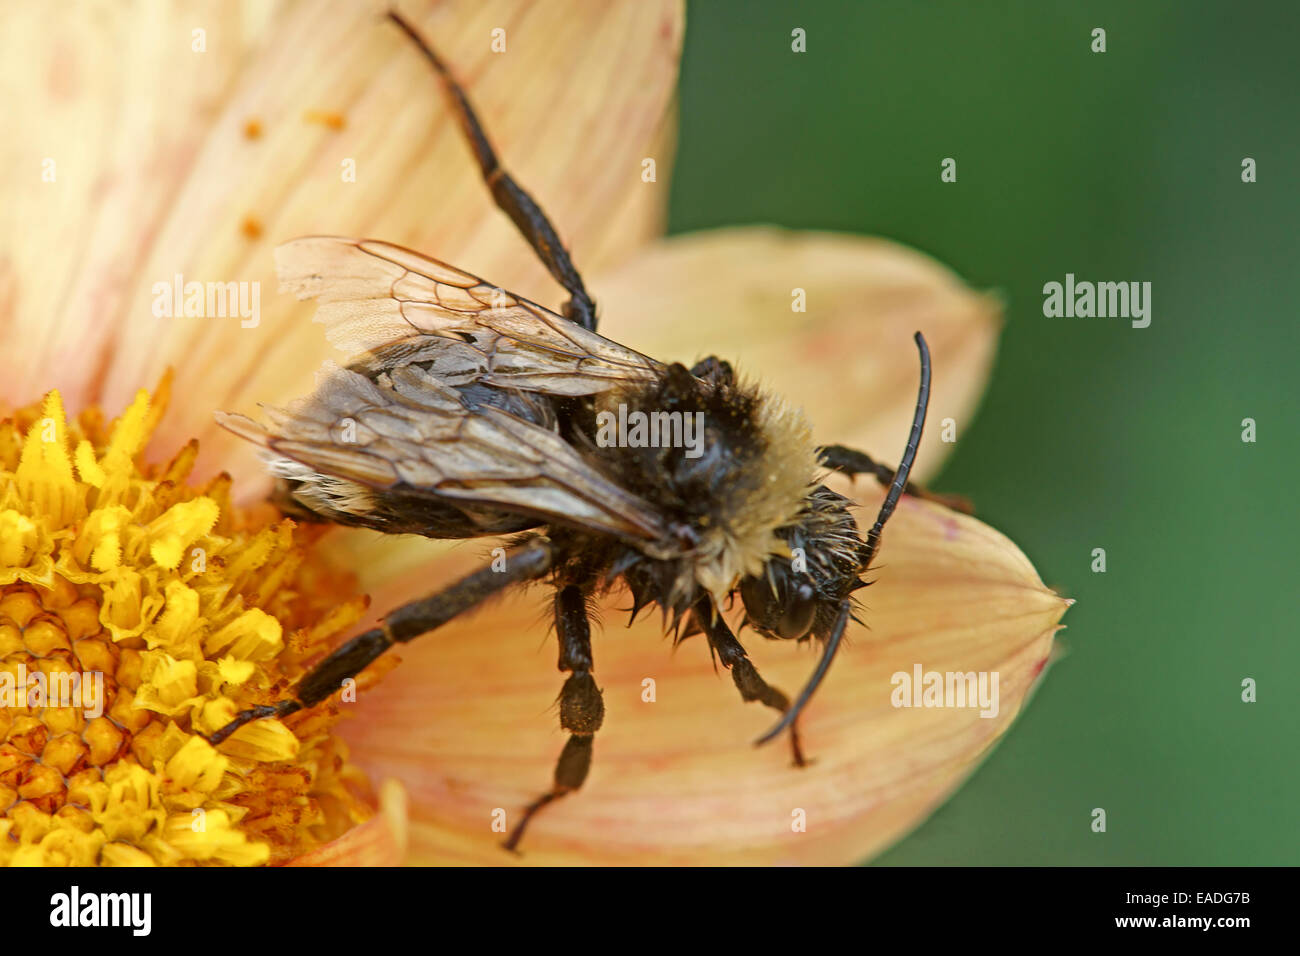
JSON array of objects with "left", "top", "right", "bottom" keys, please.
[{"left": 276, "top": 235, "right": 663, "bottom": 395}]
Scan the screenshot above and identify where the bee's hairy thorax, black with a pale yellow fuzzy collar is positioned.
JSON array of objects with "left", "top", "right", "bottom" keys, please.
[{"left": 562, "top": 359, "right": 818, "bottom": 613}]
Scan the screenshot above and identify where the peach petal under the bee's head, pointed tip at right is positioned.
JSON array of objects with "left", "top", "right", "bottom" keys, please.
[{"left": 343, "top": 483, "right": 1067, "bottom": 865}]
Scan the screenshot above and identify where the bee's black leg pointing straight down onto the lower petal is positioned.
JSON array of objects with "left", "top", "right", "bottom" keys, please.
[{"left": 502, "top": 584, "right": 605, "bottom": 851}]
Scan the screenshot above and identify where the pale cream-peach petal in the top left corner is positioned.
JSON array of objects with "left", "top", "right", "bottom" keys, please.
[{"left": 0, "top": 3, "right": 250, "bottom": 410}]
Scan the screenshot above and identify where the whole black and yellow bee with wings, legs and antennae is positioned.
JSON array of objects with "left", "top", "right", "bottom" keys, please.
[{"left": 209, "top": 12, "right": 946, "bottom": 851}]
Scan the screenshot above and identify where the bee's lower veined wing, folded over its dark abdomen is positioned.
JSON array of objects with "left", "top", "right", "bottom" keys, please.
[{"left": 217, "top": 363, "right": 666, "bottom": 541}]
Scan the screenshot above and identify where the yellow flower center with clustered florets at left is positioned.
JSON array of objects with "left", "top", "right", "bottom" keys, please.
[{"left": 0, "top": 380, "right": 384, "bottom": 866}]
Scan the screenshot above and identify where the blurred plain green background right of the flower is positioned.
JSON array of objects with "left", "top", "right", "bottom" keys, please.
[{"left": 671, "top": 0, "right": 1300, "bottom": 865}]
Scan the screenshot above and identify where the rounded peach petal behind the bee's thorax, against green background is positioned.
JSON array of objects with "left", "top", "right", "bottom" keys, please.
[{"left": 593, "top": 226, "right": 1001, "bottom": 479}]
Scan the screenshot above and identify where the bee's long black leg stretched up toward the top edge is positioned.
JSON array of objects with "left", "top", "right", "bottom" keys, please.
[{"left": 389, "top": 10, "right": 595, "bottom": 332}]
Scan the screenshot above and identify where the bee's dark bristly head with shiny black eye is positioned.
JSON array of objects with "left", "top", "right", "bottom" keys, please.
[{"left": 740, "top": 485, "right": 866, "bottom": 640}]
